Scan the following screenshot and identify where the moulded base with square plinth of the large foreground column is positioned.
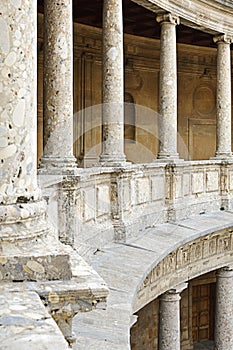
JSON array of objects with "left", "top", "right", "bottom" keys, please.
[{"left": 0, "top": 201, "right": 71, "bottom": 281}]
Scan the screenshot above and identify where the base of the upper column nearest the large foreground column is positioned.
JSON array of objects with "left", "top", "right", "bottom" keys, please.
[{"left": 39, "top": 156, "right": 77, "bottom": 175}]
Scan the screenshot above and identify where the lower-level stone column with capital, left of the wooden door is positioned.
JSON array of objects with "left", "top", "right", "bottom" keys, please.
[{"left": 159, "top": 283, "right": 187, "bottom": 350}]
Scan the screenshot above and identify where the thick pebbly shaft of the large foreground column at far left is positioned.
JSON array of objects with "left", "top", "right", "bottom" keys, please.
[{"left": 0, "top": 0, "right": 38, "bottom": 205}]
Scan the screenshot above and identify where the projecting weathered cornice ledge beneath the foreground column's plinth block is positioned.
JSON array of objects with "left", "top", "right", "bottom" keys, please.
[{"left": 0, "top": 247, "right": 109, "bottom": 350}]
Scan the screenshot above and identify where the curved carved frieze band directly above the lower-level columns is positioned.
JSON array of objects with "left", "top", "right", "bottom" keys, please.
[{"left": 134, "top": 228, "right": 233, "bottom": 311}]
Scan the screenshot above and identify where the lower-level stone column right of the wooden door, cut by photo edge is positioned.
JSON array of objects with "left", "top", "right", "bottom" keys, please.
[{"left": 214, "top": 267, "right": 233, "bottom": 350}]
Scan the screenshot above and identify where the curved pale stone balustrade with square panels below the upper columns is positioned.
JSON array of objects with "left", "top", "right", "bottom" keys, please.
[{"left": 40, "top": 160, "right": 233, "bottom": 249}]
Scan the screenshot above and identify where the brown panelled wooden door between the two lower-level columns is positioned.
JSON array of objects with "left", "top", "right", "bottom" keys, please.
[{"left": 192, "top": 283, "right": 215, "bottom": 343}]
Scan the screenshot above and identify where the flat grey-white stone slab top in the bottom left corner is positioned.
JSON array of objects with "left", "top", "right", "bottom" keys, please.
[{"left": 0, "top": 288, "right": 68, "bottom": 350}]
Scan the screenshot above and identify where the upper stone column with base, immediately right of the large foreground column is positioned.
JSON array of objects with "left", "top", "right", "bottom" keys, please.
[{"left": 41, "top": 0, "right": 75, "bottom": 172}]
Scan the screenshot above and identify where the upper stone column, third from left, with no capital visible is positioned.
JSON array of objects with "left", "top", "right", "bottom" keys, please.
[{"left": 100, "top": 0, "right": 126, "bottom": 166}]
